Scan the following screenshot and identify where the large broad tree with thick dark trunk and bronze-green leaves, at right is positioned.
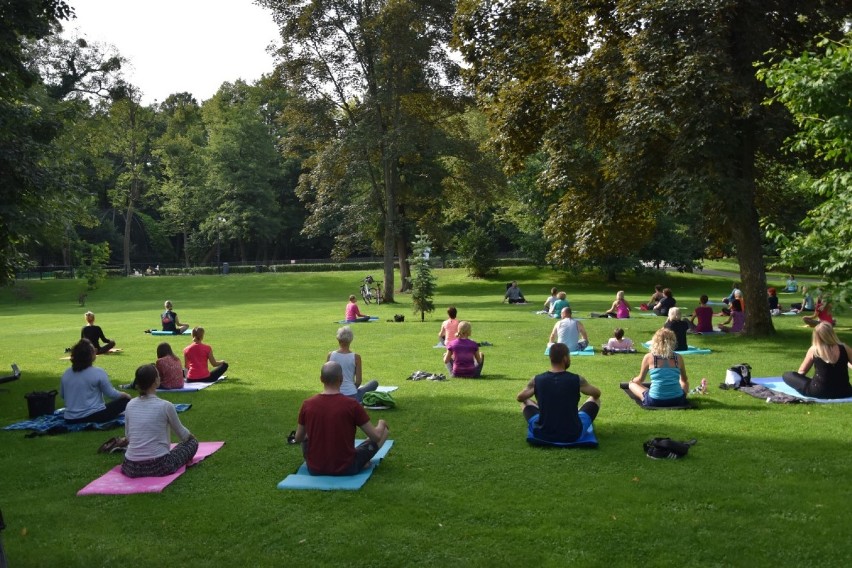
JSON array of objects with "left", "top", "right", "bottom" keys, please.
[{"left": 457, "top": 0, "right": 852, "bottom": 335}]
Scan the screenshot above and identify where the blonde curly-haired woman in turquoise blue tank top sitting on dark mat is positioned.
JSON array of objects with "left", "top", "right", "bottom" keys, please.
[{"left": 628, "top": 328, "right": 689, "bottom": 406}]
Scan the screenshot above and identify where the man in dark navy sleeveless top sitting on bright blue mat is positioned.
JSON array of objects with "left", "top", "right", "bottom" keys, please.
[{"left": 517, "top": 343, "right": 601, "bottom": 445}]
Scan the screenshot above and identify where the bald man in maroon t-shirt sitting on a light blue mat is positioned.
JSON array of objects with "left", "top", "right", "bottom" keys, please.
[{"left": 293, "top": 361, "right": 388, "bottom": 475}]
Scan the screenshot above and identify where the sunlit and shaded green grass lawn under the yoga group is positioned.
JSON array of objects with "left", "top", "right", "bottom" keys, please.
[{"left": 0, "top": 268, "right": 852, "bottom": 567}]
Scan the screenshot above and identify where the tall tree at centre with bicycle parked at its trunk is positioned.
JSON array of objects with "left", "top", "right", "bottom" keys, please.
[{"left": 257, "top": 0, "right": 457, "bottom": 301}]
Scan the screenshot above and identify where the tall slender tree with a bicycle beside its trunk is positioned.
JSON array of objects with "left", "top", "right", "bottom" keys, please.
[{"left": 258, "top": 0, "right": 470, "bottom": 302}]
